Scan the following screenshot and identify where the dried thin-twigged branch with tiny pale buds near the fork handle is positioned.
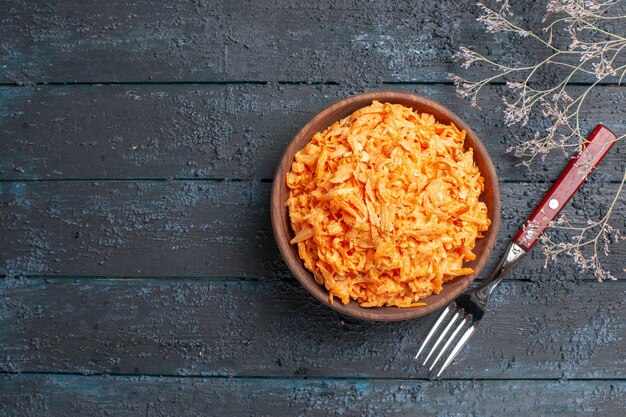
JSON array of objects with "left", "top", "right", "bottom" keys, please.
[{"left": 450, "top": 0, "right": 626, "bottom": 280}]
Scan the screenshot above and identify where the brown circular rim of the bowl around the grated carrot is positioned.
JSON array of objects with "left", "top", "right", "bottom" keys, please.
[{"left": 270, "top": 90, "right": 500, "bottom": 321}]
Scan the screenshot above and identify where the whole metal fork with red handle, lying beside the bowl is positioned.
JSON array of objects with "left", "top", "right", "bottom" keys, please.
[{"left": 415, "top": 125, "right": 617, "bottom": 378}]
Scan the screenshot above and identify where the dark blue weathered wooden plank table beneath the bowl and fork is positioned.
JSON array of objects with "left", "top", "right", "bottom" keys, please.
[{"left": 0, "top": 0, "right": 626, "bottom": 417}]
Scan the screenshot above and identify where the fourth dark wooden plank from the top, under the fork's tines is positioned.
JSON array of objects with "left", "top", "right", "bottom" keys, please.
[{"left": 0, "top": 276, "right": 626, "bottom": 379}]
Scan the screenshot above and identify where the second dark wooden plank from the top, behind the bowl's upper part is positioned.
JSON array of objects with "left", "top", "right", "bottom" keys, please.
[{"left": 0, "top": 84, "right": 626, "bottom": 181}]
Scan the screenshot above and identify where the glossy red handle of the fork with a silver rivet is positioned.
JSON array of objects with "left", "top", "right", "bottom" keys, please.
[{"left": 513, "top": 125, "right": 617, "bottom": 252}]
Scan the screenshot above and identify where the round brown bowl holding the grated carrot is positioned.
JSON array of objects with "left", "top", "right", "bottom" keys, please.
[{"left": 271, "top": 91, "right": 500, "bottom": 321}]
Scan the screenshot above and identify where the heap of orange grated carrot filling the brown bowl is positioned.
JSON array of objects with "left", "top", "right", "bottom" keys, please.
[{"left": 286, "top": 101, "right": 491, "bottom": 307}]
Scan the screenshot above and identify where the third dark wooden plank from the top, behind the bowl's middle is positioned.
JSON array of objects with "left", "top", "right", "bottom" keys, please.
[{"left": 0, "top": 181, "right": 626, "bottom": 278}]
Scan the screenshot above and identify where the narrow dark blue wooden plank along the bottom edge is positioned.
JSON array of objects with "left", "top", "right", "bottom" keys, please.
[{"left": 0, "top": 375, "right": 626, "bottom": 417}]
